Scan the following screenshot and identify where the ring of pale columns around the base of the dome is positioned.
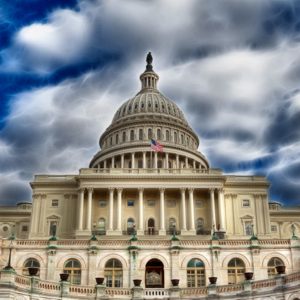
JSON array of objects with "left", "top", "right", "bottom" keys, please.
[{"left": 98, "top": 151, "right": 202, "bottom": 169}]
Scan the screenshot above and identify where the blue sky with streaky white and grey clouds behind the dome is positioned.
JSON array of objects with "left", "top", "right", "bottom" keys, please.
[{"left": 0, "top": 0, "right": 300, "bottom": 205}]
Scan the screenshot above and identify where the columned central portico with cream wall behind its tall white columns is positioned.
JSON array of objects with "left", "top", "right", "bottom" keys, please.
[{"left": 77, "top": 186, "right": 225, "bottom": 235}]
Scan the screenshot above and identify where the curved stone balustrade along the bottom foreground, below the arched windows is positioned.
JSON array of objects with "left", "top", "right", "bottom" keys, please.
[{"left": 0, "top": 270, "right": 300, "bottom": 300}]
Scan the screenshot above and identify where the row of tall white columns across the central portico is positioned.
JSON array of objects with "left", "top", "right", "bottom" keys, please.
[{"left": 78, "top": 188, "right": 225, "bottom": 234}]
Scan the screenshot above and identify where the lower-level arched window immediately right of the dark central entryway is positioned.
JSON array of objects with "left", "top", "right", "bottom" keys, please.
[{"left": 186, "top": 258, "right": 205, "bottom": 287}]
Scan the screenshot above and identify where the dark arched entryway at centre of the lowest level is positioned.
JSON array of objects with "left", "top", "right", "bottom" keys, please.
[{"left": 145, "top": 258, "right": 164, "bottom": 288}]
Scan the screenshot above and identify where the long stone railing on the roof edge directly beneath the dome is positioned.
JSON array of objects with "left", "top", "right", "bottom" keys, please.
[{"left": 79, "top": 168, "right": 222, "bottom": 175}]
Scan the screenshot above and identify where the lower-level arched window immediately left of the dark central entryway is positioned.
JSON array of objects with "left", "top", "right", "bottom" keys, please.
[{"left": 104, "top": 258, "right": 123, "bottom": 287}]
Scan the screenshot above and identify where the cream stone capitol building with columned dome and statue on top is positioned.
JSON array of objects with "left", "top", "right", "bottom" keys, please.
[{"left": 0, "top": 53, "right": 300, "bottom": 300}]
